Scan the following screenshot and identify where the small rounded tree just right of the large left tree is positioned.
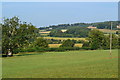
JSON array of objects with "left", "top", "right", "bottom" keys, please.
[{"left": 34, "top": 38, "right": 48, "bottom": 48}]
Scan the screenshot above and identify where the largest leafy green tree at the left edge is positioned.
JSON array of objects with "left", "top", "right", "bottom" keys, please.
[{"left": 2, "top": 17, "right": 38, "bottom": 56}]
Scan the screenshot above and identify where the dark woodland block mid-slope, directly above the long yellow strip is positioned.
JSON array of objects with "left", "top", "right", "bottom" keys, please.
[{"left": 49, "top": 27, "right": 90, "bottom": 37}]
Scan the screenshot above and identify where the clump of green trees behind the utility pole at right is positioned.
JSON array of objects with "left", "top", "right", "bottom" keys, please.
[{"left": 86, "top": 30, "right": 119, "bottom": 50}]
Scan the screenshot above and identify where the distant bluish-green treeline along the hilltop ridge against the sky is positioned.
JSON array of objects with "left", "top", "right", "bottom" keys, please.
[{"left": 39, "top": 21, "right": 120, "bottom": 31}]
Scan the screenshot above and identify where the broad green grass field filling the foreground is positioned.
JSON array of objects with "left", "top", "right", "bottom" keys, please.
[{"left": 2, "top": 50, "right": 118, "bottom": 78}]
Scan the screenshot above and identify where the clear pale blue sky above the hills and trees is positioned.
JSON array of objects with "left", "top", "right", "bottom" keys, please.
[{"left": 2, "top": 2, "right": 118, "bottom": 27}]
